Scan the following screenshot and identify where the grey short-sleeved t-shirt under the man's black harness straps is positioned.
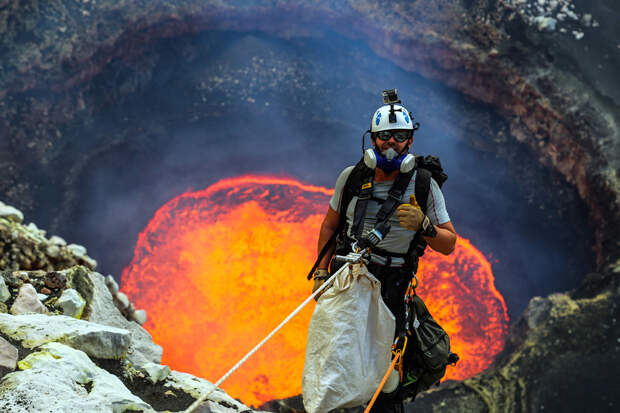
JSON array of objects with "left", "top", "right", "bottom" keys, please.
[{"left": 329, "top": 166, "right": 450, "bottom": 254}]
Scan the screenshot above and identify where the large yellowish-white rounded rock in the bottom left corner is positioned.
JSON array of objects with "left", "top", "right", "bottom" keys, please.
[{"left": 0, "top": 343, "right": 154, "bottom": 413}]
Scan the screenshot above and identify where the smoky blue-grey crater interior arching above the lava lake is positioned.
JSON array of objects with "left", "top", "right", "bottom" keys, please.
[{"left": 22, "top": 32, "right": 594, "bottom": 316}]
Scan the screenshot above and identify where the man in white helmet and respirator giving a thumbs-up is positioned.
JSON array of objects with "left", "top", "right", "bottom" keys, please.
[{"left": 313, "top": 96, "right": 456, "bottom": 413}]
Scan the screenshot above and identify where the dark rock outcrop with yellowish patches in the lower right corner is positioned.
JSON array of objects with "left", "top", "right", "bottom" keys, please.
[{"left": 415, "top": 274, "right": 620, "bottom": 412}]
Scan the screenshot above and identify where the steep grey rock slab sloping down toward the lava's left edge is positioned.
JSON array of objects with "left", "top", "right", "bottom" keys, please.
[{"left": 88, "top": 272, "right": 162, "bottom": 367}]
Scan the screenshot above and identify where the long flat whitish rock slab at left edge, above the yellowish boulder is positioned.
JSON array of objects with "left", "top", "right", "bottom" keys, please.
[{"left": 0, "top": 314, "right": 131, "bottom": 359}]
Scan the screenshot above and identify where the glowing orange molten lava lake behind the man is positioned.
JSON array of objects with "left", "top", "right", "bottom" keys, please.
[{"left": 122, "top": 176, "right": 508, "bottom": 406}]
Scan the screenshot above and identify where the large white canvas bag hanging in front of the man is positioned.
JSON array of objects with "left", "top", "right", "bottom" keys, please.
[{"left": 302, "top": 264, "right": 396, "bottom": 413}]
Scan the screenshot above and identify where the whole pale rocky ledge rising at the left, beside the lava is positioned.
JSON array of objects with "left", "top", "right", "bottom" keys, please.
[{"left": 0, "top": 204, "right": 262, "bottom": 413}]
